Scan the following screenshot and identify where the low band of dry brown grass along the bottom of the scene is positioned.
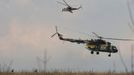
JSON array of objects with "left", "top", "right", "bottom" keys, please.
[{"left": 0, "top": 72, "right": 134, "bottom": 75}]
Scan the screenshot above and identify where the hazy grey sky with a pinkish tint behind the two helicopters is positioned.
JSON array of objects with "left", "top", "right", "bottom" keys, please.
[{"left": 0, "top": 0, "right": 134, "bottom": 71}]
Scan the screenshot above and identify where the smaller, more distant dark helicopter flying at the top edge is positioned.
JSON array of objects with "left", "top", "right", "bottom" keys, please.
[{"left": 57, "top": 0, "right": 82, "bottom": 13}]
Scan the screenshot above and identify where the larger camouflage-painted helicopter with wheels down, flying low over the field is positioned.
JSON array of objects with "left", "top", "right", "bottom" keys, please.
[{"left": 51, "top": 26, "right": 134, "bottom": 57}]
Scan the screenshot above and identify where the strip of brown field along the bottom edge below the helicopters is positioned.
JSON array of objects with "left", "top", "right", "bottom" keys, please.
[{"left": 0, "top": 72, "right": 134, "bottom": 75}]
